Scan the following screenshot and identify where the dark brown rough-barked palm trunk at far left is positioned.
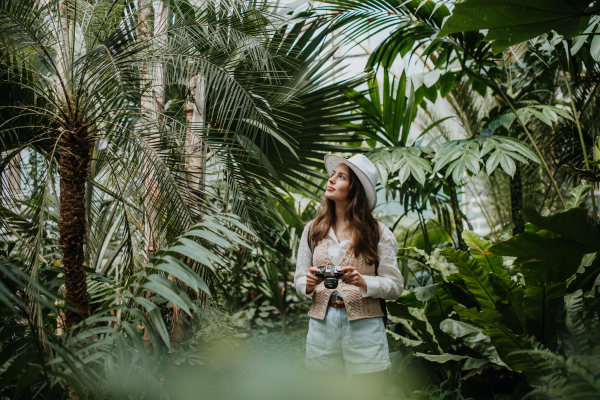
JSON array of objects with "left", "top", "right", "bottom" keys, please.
[{"left": 58, "top": 126, "right": 91, "bottom": 327}]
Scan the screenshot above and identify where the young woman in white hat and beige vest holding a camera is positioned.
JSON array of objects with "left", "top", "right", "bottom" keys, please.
[{"left": 294, "top": 154, "right": 404, "bottom": 382}]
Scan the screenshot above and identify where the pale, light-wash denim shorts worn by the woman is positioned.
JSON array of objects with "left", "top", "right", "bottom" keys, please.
[{"left": 306, "top": 307, "right": 391, "bottom": 374}]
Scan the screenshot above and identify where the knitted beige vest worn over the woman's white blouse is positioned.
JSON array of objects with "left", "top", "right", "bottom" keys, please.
[{"left": 308, "top": 222, "right": 383, "bottom": 321}]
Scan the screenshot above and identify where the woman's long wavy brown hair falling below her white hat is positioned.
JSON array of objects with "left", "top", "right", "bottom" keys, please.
[{"left": 312, "top": 168, "right": 379, "bottom": 264}]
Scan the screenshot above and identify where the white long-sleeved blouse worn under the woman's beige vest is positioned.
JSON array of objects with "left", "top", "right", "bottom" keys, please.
[{"left": 294, "top": 224, "right": 404, "bottom": 300}]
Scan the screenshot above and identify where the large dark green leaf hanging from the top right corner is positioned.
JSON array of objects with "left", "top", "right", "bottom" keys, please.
[{"left": 438, "top": 0, "right": 600, "bottom": 53}]
